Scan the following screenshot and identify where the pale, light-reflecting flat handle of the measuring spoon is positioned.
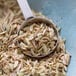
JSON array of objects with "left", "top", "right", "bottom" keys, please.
[{"left": 17, "top": 0, "right": 34, "bottom": 20}]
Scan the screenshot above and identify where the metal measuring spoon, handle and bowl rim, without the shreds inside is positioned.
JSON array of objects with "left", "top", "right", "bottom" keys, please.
[{"left": 17, "top": 0, "right": 58, "bottom": 59}]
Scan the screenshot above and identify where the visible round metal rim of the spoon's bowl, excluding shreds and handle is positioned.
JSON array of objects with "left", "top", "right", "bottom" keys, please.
[{"left": 18, "top": 17, "right": 58, "bottom": 59}]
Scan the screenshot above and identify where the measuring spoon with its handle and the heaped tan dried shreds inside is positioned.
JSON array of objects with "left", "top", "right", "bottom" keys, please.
[{"left": 17, "top": 0, "right": 58, "bottom": 58}]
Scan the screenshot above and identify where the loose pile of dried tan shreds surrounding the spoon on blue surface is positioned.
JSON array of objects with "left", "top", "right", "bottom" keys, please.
[{"left": 0, "top": 0, "right": 70, "bottom": 76}]
